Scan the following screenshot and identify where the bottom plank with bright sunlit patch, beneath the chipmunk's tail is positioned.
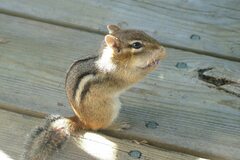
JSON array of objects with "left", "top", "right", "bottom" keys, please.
[{"left": 0, "top": 110, "right": 204, "bottom": 160}]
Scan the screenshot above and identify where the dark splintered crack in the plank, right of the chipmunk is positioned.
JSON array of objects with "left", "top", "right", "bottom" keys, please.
[{"left": 198, "top": 67, "right": 240, "bottom": 97}]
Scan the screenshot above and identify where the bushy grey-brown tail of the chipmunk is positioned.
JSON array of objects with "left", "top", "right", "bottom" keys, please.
[{"left": 22, "top": 115, "right": 77, "bottom": 160}]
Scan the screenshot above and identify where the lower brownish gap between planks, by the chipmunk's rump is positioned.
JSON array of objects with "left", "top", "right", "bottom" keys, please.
[{"left": 0, "top": 103, "right": 221, "bottom": 160}]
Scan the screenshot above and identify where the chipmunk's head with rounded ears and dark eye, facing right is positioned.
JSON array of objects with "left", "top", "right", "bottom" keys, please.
[{"left": 95, "top": 25, "right": 165, "bottom": 78}]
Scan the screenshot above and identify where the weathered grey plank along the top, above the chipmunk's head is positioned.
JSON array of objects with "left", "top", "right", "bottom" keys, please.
[{"left": 0, "top": 0, "right": 240, "bottom": 61}]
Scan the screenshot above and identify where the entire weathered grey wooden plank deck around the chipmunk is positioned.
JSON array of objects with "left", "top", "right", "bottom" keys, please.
[{"left": 0, "top": 0, "right": 240, "bottom": 160}]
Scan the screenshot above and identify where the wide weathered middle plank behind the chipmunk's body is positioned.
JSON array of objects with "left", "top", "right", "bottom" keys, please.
[{"left": 0, "top": 15, "right": 240, "bottom": 159}]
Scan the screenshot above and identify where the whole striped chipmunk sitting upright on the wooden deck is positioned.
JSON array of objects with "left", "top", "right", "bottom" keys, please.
[{"left": 23, "top": 25, "right": 165, "bottom": 160}]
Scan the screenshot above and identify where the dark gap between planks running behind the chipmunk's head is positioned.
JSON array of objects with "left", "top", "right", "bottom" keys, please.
[{"left": 0, "top": 9, "right": 240, "bottom": 62}]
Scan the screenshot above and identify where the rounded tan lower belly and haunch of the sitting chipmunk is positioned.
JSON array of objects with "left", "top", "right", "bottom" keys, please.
[{"left": 80, "top": 88, "right": 121, "bottom": 130}]
